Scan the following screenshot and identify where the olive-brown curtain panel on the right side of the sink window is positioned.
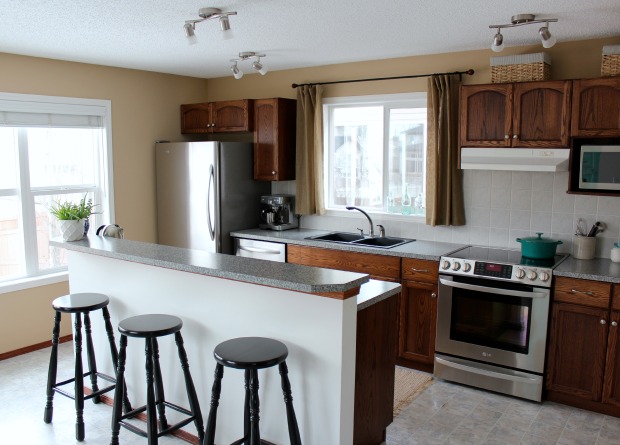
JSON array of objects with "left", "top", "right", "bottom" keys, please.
[{"left": 426, "top": 74, "right": 465, "bottom": 226}]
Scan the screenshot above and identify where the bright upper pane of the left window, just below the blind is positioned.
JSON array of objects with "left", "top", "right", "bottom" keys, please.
[{"left": 28, "top": 128, "right": 101, "bottom": 187}]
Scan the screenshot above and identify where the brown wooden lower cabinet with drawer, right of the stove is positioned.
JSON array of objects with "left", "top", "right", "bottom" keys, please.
[{"left": 545, "top": 277, "right": 620, "bottom": 416}]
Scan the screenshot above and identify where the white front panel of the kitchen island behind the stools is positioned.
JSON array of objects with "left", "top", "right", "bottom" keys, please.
[{"left": 69, "top": 251, "right": 357, "bottom": 445}]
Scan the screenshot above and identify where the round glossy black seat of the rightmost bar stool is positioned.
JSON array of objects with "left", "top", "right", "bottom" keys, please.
[{"left": 213, "top": 337, "right": 288, "bottom": 369}]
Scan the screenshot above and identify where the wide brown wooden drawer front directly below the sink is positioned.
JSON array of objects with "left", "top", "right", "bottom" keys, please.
[{"left": 287, "top": 244, "right": 400, "bottom": 281}]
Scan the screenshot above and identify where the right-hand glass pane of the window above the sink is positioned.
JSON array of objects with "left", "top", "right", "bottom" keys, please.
[{"left": 387, "top": 108, "right": 426, "bottom": 215}]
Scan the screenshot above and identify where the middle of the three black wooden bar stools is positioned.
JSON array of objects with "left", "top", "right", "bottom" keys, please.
[{"left": 110, "top": 314, "right": 204, "bottom": 445}]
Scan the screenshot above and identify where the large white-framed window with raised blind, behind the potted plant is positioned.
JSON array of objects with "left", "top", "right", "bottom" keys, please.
[{"left": 0, "top": 93, "right": 113, "bottom": 291}]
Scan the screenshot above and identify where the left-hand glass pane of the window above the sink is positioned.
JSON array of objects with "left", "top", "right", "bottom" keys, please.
[{"left": 328, "top": 107, "right": 383, "bottom": 209}]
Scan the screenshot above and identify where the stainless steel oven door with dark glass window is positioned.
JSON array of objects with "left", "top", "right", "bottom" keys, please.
[{"left": 435, "top": 275, "right": 549, "bottom": 374}]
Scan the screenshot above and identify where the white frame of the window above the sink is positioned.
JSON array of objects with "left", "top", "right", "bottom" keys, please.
[{"left": 322, "top": 91, "right": 427, "bottom": 222}]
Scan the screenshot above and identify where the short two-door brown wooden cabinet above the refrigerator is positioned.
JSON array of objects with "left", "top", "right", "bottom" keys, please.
[{"left": 181, "top": 99, "right": 254, "bottom": 134}]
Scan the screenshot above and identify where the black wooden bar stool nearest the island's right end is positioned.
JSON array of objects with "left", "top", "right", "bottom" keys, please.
[{"left": 204, "top": 337, "right": 301, "bottom": 445}]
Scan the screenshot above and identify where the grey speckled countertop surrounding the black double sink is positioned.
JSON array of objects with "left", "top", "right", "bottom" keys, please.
[{"left": 230, "top": 229, "right": 467, "bottom": 261}]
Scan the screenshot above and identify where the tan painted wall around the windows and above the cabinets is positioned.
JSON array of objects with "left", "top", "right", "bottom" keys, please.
[{"left": 0, "top": 36, "right": 620, "bottom": 353}]
